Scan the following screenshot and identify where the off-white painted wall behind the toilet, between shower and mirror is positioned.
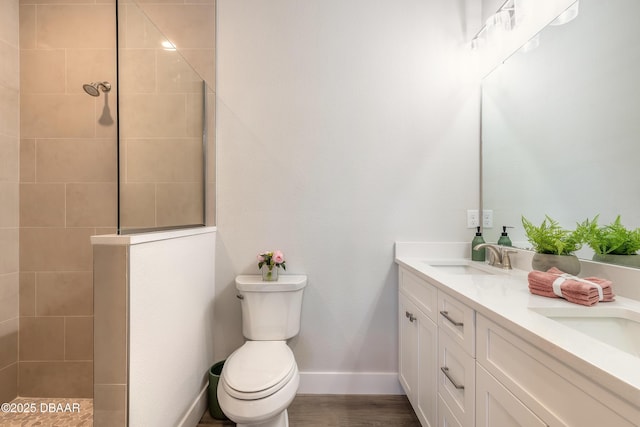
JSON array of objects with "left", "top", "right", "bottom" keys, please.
[{"left": 215, "top": 0, "right": 480, "bottom": 393}]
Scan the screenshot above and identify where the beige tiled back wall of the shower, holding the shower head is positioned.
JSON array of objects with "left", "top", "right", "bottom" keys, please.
[{"left": 19, "top": 0, "right": 117, "bottom": 397}]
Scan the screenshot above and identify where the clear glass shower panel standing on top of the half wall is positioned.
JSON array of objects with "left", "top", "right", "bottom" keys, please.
[{"left": 118, "top": 0, "right": 207, "bottom": 234}]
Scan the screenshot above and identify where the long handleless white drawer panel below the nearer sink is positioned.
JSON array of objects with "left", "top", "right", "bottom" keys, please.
[{"left": 478, "top": 316, "right": 640, "bottom": 427}]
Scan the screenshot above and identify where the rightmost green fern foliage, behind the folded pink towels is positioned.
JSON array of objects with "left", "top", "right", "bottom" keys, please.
[{"left": 581, "top": 215, "right": 640, "bottom": 267}]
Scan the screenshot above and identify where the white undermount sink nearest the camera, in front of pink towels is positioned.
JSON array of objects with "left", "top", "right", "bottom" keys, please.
[{"left": 532, "top": 307, "right": 640, "bottom": 357}]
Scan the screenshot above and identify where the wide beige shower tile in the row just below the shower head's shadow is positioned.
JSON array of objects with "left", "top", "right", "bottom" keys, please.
[{"left": 36, "top": 139, "right": 117, "bottom": 182}]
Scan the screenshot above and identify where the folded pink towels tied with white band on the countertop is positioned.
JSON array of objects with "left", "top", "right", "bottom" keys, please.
[{"left": 528, "top": 267, "right": 615, "bottom": 306}]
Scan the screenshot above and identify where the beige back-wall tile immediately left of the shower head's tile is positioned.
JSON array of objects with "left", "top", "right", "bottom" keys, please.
[{"left": 20, "top": 49, "right": 66, "bottom": 94}]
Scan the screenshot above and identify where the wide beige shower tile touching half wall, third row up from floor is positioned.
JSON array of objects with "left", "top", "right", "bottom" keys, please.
[{"left": 35, "top": 271, "right": 93, "bottom": 316}]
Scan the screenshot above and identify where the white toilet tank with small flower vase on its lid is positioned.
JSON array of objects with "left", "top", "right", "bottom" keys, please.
[{"left": 236, "top": 275, "right": 307, "bottom": 341}]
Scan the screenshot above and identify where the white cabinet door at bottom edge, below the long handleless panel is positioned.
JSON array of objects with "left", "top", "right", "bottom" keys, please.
[{"left": 476, "top": 364, "right": 546, "bottom": 427}]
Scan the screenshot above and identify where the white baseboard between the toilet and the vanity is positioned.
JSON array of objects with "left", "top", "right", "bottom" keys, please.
[{"left": 298, "top": 372, "right": 405, "bottom": 394}]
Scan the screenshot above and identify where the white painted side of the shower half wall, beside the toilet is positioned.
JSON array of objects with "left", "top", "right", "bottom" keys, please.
[{"left": 128, "top": 227, "right": 216, "bottom": 427}]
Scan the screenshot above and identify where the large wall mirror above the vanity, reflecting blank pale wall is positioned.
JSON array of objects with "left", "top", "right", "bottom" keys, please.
[{"left": 482, "top": 0, "right": 640, "bottom": 259}]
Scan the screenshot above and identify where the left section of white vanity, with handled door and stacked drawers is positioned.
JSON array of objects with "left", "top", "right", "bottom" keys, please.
[{"left": 398, "top": 268, "right": 475, "bottom": 427}]
